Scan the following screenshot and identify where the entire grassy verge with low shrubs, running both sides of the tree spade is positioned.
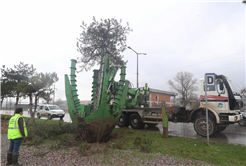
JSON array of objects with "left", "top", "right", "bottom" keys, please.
[{"left": 0, "top": 115, "right": 246, "bottom": 166}]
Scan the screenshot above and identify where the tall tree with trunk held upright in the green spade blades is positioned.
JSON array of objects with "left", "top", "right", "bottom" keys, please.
[{"left": 77, "top": 17, "right": 132, "bottom": 112}]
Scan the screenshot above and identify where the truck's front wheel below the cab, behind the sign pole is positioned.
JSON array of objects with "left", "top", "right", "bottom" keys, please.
[{"left": 194, "top": 116, "right": 217, "bottom": 137}]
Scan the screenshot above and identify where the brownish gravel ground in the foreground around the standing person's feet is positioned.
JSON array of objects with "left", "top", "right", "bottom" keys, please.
[{"left": 0, "top": 120, "right": 210, "bottom": 166}]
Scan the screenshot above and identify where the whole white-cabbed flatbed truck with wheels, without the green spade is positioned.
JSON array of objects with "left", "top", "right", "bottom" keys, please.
[{"left": 118, "top": 75, "right": 243, "bottom": 137}]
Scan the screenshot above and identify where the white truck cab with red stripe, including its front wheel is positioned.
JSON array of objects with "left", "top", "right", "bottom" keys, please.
[{"left": 190, "top": 74, "right": 243, "bottom": 137}]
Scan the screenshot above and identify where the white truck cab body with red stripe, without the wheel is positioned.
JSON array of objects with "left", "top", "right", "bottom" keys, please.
[{"left": 200, "top": 75, "right": 243, "bottom": 124}]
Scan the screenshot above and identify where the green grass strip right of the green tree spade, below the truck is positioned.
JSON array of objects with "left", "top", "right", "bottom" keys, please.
[{"left": 113, "top": 128, "right": 246, "bottom": 166}]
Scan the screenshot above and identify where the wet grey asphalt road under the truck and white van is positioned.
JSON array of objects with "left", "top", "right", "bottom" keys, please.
[{"left": 0, "top": 110, "right": 246, "bottom": 146}]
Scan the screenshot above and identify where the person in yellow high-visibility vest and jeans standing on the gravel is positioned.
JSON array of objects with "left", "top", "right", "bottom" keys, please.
[{"left": 6, "top": 108, "right": 27, "bottom": 165}]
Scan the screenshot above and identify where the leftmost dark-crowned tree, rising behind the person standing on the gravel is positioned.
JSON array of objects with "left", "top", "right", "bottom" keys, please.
[{"left": 1, "top": 62, "right": 36, "bottom": 108}]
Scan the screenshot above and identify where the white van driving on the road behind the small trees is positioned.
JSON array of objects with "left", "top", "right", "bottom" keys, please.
[{"left": 37, "top": 104, "right": 65, "bottom": 119}]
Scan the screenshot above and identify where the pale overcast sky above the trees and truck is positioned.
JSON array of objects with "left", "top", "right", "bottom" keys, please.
[{"left": 0, "top": 0, "right": 246, "bottom": 103}]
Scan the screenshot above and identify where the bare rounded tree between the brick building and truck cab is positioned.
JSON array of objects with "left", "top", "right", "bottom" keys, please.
[{"left": 168, "top": 72, "right": 198, "bottom": 104}]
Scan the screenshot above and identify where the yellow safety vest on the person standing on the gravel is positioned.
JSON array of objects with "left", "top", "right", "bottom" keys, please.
[{"left": 8, "top": 114, "right": 27, "bottom": 139}]
